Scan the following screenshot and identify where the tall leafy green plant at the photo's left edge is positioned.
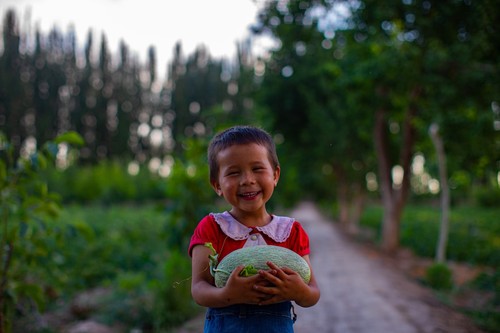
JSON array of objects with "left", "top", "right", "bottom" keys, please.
[{"left": 0, "top": 132, "right": 81, "bottom": 331}]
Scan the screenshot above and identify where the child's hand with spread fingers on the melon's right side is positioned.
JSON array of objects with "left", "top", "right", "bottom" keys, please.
[{"left": 254, "top": 262, "right": 309, "bottom": 305}]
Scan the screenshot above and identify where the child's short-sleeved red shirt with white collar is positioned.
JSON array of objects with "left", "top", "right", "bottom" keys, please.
[{"left": 188, "top": 212, "right": 310, "bottom": 262}]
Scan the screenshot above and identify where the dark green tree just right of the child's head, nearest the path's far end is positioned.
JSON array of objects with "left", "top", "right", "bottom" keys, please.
[{"left": 255, "top": 1, "right": 373, "bottom": 222}]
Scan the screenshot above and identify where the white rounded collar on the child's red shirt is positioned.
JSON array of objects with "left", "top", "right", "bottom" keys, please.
[{"left": 210, "top": 211, "right": 295, "bottom": 243}]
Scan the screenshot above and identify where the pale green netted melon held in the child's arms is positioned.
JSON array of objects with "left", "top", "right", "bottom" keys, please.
[{"left": 213, "top": 245, "right": 311, "bottom": 287}]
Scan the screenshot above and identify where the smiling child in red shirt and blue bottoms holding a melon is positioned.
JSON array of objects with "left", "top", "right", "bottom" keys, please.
[{"left": 189, "top": 126, "right": 320, "bottom": 333}]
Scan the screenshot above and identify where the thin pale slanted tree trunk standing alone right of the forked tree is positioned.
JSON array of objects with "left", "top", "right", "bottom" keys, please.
[{"left": 429, "top": 123, "right": 450, "bottom": 263}]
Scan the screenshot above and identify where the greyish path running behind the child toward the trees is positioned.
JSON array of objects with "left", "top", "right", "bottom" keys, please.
[{"left": 176, "top": 203, "right": 482, "bottom": 333}]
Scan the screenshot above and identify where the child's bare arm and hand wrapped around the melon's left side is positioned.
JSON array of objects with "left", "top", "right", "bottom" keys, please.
[{"left": 191, "top": 245, "right": 278, "bottom": 308}]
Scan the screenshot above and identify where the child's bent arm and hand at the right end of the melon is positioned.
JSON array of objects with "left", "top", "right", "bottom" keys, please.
[{"left": 253, "top": 255, "right": 320, "bottom": 307}]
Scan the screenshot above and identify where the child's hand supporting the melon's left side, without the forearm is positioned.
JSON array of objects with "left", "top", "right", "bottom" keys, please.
[{"left": 223, "top": 266, "right": 273, "bottom": 304}]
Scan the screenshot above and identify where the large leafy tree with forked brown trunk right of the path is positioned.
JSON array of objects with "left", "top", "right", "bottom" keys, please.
[{"left": 352, "top": 0, "right": 498, "bottom": 251}]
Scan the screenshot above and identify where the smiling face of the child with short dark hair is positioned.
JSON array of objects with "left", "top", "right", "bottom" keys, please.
[{"left": 212, "top": 143, "right": 280, "bottom": 218}]
